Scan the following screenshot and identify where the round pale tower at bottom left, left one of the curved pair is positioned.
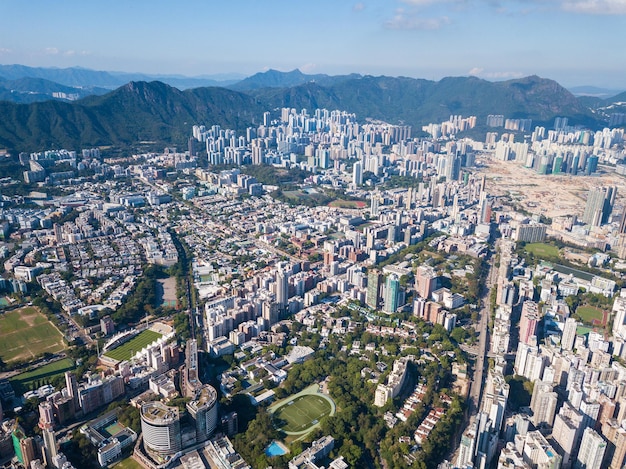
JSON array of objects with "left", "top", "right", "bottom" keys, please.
[{"left": 141, "top": 401, "right": 182, "bottom": 455}]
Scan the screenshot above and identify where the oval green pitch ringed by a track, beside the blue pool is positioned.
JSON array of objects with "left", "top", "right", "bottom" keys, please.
[{"left": 273, "top": 394, "right": 332, "bottom": 434}]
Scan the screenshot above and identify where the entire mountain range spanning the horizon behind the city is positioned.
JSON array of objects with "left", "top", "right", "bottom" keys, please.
[{"left": 0, "top": 66, "right": 626, "bottom": 151}]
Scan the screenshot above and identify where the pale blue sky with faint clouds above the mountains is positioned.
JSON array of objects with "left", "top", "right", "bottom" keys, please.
[{"left": 0, "top": 0, "right": 626, "bottom": 90}]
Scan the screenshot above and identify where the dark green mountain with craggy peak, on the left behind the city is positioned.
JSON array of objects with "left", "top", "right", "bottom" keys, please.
[{"left": 0, "top": 82, "right": 265, "bottom": 151}]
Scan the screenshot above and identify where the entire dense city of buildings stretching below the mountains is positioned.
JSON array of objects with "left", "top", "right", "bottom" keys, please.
[{"left": 0, "top": 108, "right": 626, "bottom": 469}]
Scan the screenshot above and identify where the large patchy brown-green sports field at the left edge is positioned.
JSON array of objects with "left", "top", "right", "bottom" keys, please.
[{"left": 0, "top": 306, "right": 65, "bottom": 363}]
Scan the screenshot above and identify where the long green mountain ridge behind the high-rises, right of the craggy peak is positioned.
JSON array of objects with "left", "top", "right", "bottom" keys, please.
[{"left": 249, "top": 76, "right": 596, "bottom": 128}]
